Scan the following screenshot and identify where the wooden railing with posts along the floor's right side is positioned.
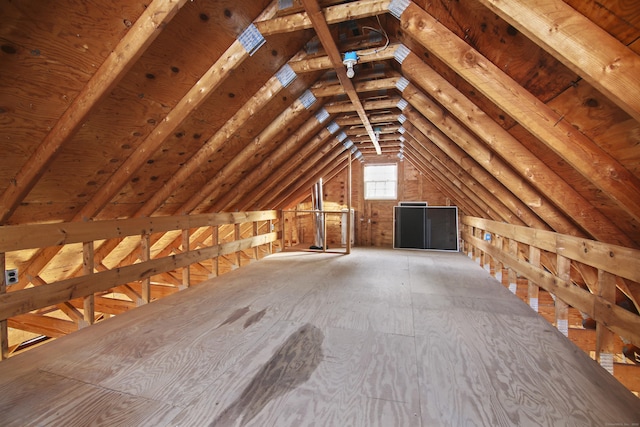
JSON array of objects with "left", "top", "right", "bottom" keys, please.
[{"left": 462, "top": 217, "right": 640, "bottom": 384}]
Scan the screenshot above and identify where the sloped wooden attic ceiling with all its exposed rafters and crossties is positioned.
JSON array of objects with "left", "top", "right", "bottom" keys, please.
[{"left": 0, "top": 0, "right": 640, "bottom": 247}]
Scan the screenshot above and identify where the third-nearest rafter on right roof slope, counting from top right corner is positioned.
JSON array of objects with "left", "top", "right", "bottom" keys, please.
[{"left": 402, "top": 53, "right": 636, "bottom": 247}]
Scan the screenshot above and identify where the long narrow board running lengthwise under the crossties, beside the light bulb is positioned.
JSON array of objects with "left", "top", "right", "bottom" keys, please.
[{"left": 302, "top": 0, "right": 380, "bottom": 154}]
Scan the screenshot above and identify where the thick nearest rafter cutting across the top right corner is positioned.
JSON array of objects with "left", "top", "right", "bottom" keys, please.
[{"left": 480, "top": 0, "right": 640, "bottom": 121}]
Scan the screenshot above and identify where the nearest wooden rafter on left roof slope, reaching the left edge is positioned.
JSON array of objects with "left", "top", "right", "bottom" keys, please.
[{"left": 0, "top": 0, "right": 186, "bottom": 224}]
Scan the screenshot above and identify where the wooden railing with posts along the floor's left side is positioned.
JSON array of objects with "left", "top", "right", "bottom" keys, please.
[{"left": 0, "top": 211, "right": 279, "bottom": 358}]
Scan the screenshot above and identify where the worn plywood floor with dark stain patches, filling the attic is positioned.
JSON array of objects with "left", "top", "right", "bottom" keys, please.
[{"left": 0, "top": 249, "right": 640, "bottom": 427}]
